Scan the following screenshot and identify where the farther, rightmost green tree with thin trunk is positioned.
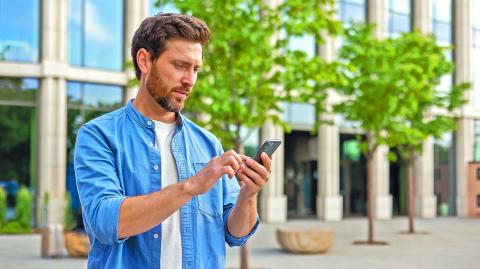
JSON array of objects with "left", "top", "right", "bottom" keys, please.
[{"left": 387, "top": 31, "right": 470, "bottom": 233}]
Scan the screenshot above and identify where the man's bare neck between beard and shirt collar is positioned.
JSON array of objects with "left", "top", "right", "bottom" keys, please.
[{"left": 133, "top": 87, "right": 176, "bottom": 123}]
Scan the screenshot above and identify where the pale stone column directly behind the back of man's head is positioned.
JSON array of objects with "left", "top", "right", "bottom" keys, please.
[{"left": 123, "top": 0, "right": 149, "bottom": 103}]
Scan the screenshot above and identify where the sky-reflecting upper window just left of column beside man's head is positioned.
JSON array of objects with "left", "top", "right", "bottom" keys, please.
[{"left": 68, "top": 0, "right": 124, "bottom": 71}]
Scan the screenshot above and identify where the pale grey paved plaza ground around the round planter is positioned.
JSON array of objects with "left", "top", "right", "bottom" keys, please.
[{"left": 0, "top": 218, "right": 480, "bottom": 269}]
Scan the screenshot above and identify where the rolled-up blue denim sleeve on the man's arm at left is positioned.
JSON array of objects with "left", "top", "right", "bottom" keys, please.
[{"left": 75, "top": 125, "right": 127, "bottom": 245}]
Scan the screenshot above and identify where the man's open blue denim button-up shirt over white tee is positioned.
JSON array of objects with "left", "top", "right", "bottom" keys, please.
[{"left": 75, "top": 101, "right": 259, "bottom": 269}]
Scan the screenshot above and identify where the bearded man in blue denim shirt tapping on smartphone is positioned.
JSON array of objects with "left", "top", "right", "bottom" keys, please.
[{"left": 75, "top": 14, "right": 270, "bottom": 269}]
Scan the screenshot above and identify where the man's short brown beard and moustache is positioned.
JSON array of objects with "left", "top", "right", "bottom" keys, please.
[{"left": 146, "top": 68, "right": 190, "bottom": 113}]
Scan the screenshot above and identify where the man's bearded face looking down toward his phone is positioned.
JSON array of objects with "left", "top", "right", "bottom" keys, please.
[{"left": 146, "top": 39, "right": 202, "bottom": 112}]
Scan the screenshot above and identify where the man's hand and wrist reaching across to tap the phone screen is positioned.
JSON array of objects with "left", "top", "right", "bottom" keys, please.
[{"left": 185, "top": 150, "right": 242, "bottom": 196}]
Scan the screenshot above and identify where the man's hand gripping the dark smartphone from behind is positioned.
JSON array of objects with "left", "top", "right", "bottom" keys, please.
[{"left": 237, "top": 152, "right": 271, "bottom": 199}]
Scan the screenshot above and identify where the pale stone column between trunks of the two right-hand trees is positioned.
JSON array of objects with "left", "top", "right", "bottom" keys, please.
[{"left": 367, "top": 0, "right": 392, "bottom": 219}]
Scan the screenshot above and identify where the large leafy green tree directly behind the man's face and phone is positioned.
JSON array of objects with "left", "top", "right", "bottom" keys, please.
[{"left": 148, "top": 0, "right": 342, "bottom": 268}]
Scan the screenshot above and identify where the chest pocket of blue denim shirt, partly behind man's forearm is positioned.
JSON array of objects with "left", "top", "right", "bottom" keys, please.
[{"left": 193, "top": 163, "right": 223, "bottom": 218}]
